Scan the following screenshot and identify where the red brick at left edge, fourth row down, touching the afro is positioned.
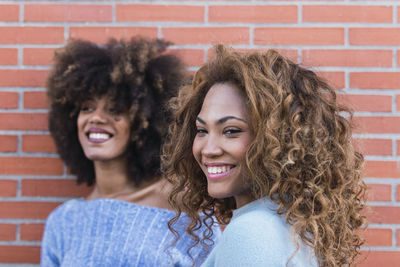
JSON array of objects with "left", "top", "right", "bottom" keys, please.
[{"left": 0, "top": 70, "right": 49, "bottom": 87}]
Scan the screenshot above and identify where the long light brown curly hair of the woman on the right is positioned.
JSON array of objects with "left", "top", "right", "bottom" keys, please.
[{"left": 163, "top": 45, "right": 366, "bottom": 266}]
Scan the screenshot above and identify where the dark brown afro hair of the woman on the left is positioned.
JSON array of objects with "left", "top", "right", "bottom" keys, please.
[{"left": 46, "top": 37, "right": 187, "bottom": 186}]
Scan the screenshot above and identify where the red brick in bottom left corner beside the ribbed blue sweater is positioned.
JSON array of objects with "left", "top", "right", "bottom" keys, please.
[{"left": 0, "top": 245, "right": 40, "bottom": 263}]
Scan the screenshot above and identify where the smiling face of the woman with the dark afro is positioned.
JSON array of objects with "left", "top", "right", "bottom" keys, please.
[{"left": 77, "top": 96, "right": 130, "bottom": 161}]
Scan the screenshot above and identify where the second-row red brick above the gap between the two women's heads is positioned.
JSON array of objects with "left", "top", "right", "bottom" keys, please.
[{"left": 162, "top": 27, "right": 250, "bottom": 44}]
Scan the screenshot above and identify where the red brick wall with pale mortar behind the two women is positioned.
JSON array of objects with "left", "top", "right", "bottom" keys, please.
[{"left": 0, "top": 0, "right": 400, "bottom": 267}]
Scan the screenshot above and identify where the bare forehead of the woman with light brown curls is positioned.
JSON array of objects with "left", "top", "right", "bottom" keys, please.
[{"left": 199, "top": 83, "right": 248, "bottom": 119}]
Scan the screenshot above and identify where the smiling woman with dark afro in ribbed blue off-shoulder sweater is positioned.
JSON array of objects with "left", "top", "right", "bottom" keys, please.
[{"left": 41, "top": 37, "right": 219, "bottom": 266}]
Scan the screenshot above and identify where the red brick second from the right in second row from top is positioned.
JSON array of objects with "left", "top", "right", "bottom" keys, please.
[{"left": 254, "top": 28, "right": 344, "bottom": 45}]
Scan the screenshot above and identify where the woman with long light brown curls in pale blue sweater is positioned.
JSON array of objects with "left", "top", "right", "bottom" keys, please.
[{"left": 163, "top": 45, "right": 366, "bottom": 267}]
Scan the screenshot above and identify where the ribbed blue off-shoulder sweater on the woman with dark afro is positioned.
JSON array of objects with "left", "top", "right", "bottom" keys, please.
[{"left": 41, "top": 199, "right": 220, "bottom": 267}]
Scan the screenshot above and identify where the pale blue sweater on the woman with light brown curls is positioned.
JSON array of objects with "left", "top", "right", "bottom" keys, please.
[{"left": 202, "top": 198, "right": 318, "bottom": 267}]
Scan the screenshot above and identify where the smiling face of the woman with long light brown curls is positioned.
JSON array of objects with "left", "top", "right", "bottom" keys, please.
[{"left": 192, "top": 83, "right": 254, "bottom": 207}]
